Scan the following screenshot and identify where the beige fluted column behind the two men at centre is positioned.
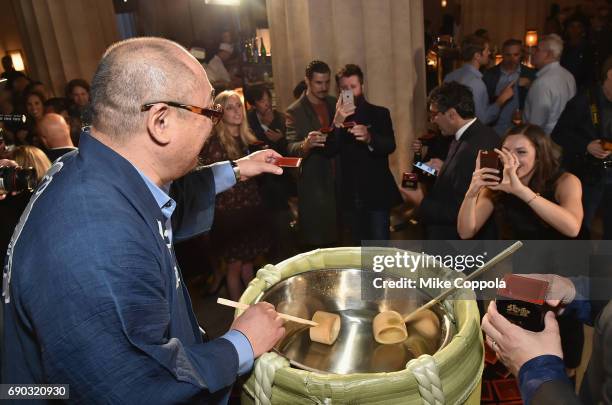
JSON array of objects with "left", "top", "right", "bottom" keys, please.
[{"left": 267, "top": 0, "right": 426, "bottom": 178}]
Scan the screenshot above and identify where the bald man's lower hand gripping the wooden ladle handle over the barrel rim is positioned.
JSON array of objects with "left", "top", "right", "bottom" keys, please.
[{"left": 230, "top": 302, "right": 285, "bottom": 358}]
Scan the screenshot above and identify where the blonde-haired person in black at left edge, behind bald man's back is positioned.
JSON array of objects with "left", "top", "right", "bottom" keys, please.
[{"left": 0, "top": 146, "right": 51, "bottom": 257}]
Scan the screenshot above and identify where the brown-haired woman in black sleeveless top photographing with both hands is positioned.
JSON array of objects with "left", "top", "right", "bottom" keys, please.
[{"left": 457, "top": 124, "right": 583, "bottom": 240}]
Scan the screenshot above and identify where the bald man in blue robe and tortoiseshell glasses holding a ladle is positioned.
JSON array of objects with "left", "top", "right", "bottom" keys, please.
[{"left": 2, "top": 38, "right": 284, "bottom": 404}]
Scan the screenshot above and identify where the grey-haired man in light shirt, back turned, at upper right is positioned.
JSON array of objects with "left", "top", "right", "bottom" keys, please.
[{"left": 523, "top": 34, "right": 576, "bottom": 135}]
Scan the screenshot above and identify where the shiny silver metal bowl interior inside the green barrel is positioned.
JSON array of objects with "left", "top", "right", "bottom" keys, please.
[{"left": 261, "top": 269, "right": 455, "bottom": 374}]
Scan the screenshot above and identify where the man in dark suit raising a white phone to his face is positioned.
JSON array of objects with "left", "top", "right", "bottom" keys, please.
[{"left": 333, "top": 64, "right": 402, "bottom": 241}]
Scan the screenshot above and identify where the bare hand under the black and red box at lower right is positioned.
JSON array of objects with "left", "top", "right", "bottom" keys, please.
[{"left": 482, "top": 301, "right": 563, "bottom": 376}]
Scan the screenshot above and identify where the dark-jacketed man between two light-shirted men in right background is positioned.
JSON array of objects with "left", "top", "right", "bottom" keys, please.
[{"left": 482, "top": 39, "right": 536, "bottom": 136}]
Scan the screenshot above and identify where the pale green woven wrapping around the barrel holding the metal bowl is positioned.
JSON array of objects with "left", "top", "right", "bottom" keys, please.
[{"left": 236, "top": 248, "right": 484, "bottom": 405}]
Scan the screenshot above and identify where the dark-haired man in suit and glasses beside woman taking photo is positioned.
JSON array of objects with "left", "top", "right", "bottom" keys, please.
[{"left": 400, "top": 82, "right": 500, "bottom": 240}]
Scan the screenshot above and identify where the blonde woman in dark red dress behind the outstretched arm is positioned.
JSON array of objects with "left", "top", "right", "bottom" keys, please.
[{"left": 200, "top": 91, "right": 269, "bottom": 300}]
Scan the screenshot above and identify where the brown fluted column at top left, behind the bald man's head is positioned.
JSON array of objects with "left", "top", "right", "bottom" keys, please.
[{"left": 7, "top": 0, "right": 119, "bottom": 96}]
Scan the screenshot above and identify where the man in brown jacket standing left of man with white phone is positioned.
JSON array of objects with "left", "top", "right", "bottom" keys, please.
[{"left": 287, "top": 60, "right": 353, "bottom": 248}]
